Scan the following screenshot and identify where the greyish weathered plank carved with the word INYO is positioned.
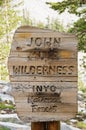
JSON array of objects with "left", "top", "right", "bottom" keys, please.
[{"left": 11, "top": 82, "right": 77, "bottom": 99}]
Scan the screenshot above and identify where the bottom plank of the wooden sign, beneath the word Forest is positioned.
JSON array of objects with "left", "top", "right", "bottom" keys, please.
[{"left": 17, "top": 103, "right": 77, "bottom": 121}]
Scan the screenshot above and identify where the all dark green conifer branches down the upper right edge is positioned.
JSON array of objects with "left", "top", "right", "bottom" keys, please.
[{"left": 47, "top": 0, "right": 86, "bottom": 52}]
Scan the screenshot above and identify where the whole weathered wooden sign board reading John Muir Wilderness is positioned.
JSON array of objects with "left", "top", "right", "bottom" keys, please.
[{"left": 8, "top": 26, "right": 77, "bottom": 122}]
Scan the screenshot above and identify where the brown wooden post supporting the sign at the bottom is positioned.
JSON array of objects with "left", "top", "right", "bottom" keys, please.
[{"left": 31, "top": 121, "right": 60, "bottom": 130}]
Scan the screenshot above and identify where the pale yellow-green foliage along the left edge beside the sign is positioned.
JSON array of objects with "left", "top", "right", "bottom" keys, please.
[{"left": 0, "top": 0, "right": 22, "bottom": 80}]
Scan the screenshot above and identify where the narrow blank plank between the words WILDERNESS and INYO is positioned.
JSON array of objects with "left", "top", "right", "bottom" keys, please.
[{"left": 10, "top": 75, "right": 77, "bottom": 82}]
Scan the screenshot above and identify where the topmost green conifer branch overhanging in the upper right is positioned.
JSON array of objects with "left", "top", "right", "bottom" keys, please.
[{"left": 46, "top": 0, "right": 86, "bottom": 15}]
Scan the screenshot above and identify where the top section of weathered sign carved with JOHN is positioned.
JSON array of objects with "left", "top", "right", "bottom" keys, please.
[{"left": 11, "top": 27, "right": 77, "bottom": 52}]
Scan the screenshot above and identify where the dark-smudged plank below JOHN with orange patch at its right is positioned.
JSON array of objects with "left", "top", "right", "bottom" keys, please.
[{"left": 9, "top": 49, "right": 77, "bottom": 59}]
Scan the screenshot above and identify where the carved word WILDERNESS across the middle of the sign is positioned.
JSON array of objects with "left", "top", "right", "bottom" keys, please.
[{"left": 13, "top": 65, "right": 75, "bottom": 76}]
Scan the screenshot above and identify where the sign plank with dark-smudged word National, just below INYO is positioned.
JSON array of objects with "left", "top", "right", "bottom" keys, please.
[{"left": 13, "top": 89, "right": 77, "bottom": 104}]
